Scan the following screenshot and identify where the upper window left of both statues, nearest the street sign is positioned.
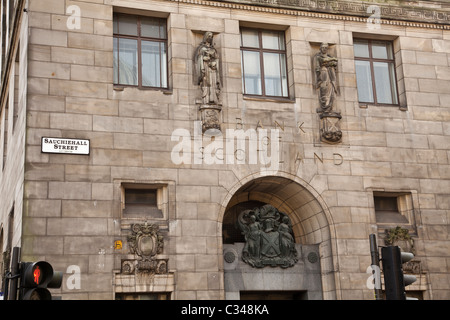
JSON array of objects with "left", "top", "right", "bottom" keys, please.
[{"left": 114, "top": 14, "right": 167, "bottom": 88}]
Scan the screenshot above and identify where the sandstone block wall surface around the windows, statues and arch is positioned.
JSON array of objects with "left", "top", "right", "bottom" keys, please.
[{"left": 2, "top": 0, "right": 450, "bottom": 299}]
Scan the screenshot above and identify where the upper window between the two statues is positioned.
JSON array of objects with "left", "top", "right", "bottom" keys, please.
[{"left": 241, "top": 29, "right": 288, "bottom": 98}]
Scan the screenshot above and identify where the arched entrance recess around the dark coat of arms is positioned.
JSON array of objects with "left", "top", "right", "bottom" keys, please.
[{"left": 222, "top": 176, "right": 336, "bottom": 299}]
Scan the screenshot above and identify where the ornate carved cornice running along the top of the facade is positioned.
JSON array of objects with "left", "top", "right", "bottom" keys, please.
[{"left": 167, "top": 0, "right": 450, "bottom": 30}]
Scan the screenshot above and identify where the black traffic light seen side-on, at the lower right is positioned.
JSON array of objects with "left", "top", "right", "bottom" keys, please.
[{"left": 381, "top": 246, "right": 417, "bottom": 300}]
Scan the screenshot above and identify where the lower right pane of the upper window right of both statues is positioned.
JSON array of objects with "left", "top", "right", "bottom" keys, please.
[{"left": 373, "top": 62, "right": 397, "bottom": 104}]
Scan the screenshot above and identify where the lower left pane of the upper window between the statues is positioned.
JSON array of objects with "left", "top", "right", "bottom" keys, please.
[{"left": 242, "top": 51, "right": 262, "bottom": 95}]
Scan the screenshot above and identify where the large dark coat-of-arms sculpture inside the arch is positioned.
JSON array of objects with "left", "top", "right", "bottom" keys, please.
[{"left": 238, "top": 205, "right": 298, "bottom": 268}]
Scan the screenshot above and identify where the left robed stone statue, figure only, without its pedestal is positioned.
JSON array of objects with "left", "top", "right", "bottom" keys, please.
[{"left": 195, "top": 31, "right": 221, "bottom": 105}]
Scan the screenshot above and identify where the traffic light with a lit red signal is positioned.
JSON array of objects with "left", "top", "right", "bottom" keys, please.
[{"left": 19, "top": 261, "right": 62, "bottom": 300}]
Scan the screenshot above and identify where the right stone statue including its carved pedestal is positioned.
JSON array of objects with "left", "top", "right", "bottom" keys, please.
[{"left": 314, "top": 43, "right": 342, "bottom": 143}]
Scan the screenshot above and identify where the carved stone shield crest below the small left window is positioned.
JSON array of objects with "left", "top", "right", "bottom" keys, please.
[{"left": 122, "top": 223, "right": 167, "bottom": 274}]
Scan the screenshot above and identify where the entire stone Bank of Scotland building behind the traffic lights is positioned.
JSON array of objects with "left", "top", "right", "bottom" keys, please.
[{"left": 0, "top": 0, "right": 450, "bottom": 300}]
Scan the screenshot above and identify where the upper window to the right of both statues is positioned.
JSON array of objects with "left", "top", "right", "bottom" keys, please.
[{"left": 353, "top": 39, "right": 398, "bottom": 105}]
